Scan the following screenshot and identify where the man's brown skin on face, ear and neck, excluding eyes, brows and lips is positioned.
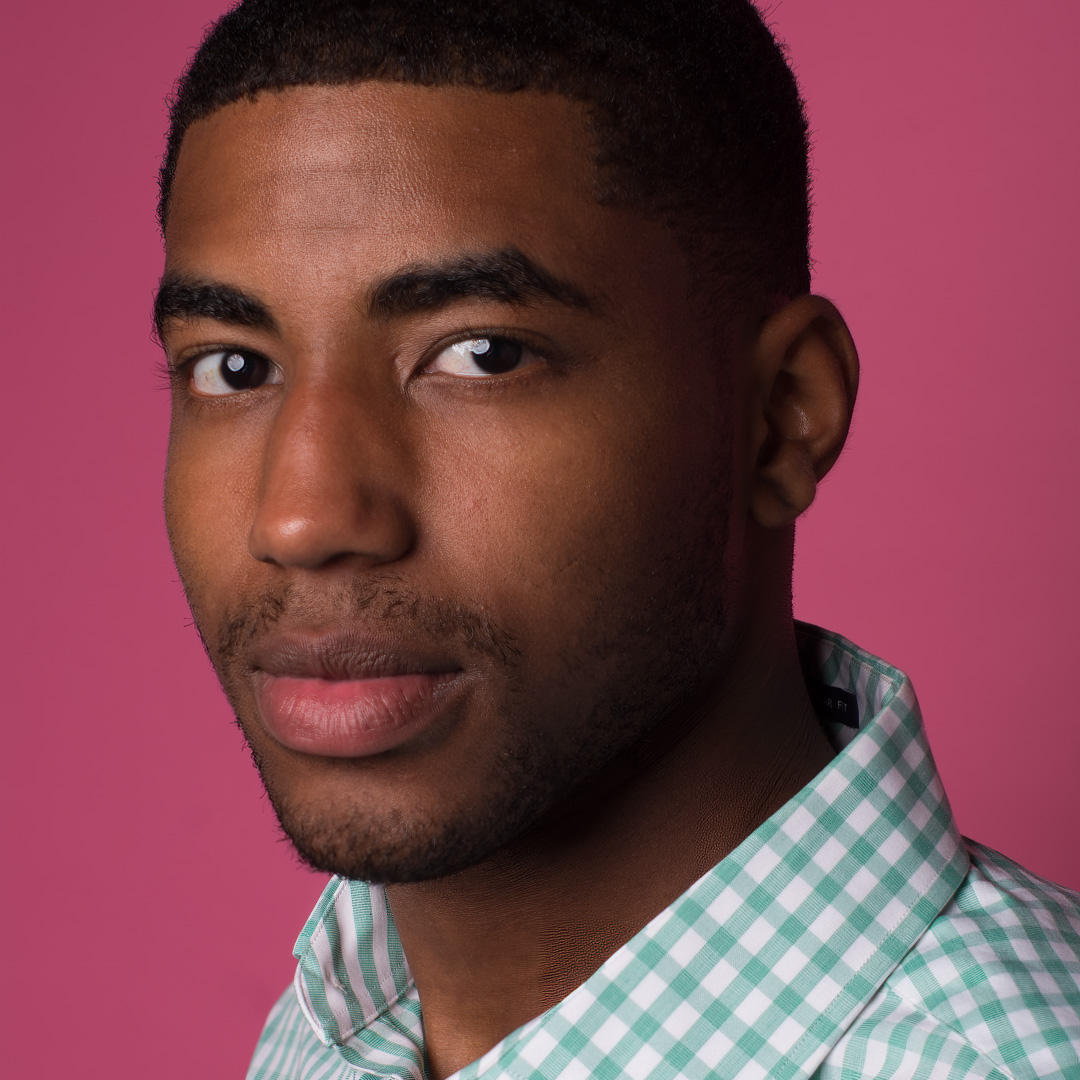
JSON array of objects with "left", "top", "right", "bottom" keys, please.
[{"left": 161, "top": 82, "right": 858, "bottom": 1080}]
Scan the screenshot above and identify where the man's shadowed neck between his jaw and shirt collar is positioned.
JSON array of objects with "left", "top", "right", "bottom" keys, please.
[{"left": 387, "top": 622, "right": 833, "bottom": 1080}]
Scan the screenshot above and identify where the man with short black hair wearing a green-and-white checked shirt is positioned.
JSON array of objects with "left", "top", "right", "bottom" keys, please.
[{"left": 156, "top": 0, "right": 1080, "bottom": 1080}]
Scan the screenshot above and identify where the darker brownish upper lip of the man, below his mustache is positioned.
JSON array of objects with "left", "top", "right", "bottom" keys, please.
[{"left": 247, "top": 627, "right": 461, "bottom": 679}]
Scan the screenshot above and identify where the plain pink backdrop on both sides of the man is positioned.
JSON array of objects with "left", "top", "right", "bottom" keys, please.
[{"left": 0, "top": 0, "right": 1080, "bottom": 1080}]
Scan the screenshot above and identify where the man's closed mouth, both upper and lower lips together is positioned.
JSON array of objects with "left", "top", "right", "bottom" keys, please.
[{"left": 251, "top": 631, "right": 462, "bottom": 757}]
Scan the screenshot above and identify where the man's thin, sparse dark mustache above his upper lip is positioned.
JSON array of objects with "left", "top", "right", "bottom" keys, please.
[{"left": 216, "top": 581, "right": 521, "bottom": 666}]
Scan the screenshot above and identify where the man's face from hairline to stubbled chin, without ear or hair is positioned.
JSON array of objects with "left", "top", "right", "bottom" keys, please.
[{"left": 163, "top": 82, "right": 745, "bottom": 880}]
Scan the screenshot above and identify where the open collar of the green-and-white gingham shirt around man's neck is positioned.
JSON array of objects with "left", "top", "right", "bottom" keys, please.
[{"left": 295, "top": 623, "right": 968, "bottom": 1080}]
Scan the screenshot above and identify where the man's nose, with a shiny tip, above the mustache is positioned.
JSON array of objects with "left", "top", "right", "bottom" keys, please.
[{"left": 248, "top": 386, "right": 416, "bottom": 569}]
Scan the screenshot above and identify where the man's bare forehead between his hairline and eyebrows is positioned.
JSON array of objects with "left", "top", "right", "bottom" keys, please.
[{"left": 166, "top": 82, "right": 603, "bottom": 259}]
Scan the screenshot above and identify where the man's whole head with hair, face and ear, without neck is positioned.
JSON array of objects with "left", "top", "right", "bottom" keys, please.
[{"left": 157, "top": 2, "right": 854, "bottom": 880}]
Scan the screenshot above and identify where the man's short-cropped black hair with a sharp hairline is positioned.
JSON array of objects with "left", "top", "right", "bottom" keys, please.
[{"left": 158, "top": 0, "right": 810, "bottom": 297}]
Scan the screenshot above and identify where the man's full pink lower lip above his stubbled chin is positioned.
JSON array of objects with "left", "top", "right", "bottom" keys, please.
[{"left": 254, "top": 672, "right": 458, "bottom": 757}]
